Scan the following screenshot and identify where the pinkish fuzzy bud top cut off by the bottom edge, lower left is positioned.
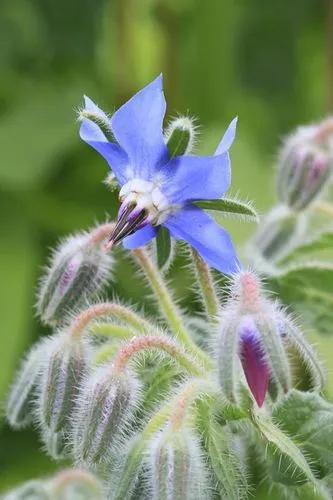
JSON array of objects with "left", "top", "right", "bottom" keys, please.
[{"left": 48, "top": 469, "right": 105, "bottom": 500}]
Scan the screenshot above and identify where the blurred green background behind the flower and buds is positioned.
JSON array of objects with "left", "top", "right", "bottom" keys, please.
[{"left": 0, "top": 0, "right": 333, "bottom": 490}]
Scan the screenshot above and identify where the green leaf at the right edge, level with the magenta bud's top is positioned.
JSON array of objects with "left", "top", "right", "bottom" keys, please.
[{"left": 269, "top": 262, "right": 333, "bottom": 334}]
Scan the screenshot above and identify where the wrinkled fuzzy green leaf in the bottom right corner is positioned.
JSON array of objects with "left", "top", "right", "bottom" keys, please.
[{"left": 273, "top": 390, "right": 333, "bottom": 477}]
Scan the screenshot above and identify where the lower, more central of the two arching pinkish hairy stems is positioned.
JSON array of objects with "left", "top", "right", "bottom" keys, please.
[{"left": 113, "top": 335, "right": 203, "bottom": 375}]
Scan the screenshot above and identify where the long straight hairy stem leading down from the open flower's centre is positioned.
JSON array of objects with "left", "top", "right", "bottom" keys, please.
[{"left": 133, "top": 248, "right": 213, "bottom": 369}]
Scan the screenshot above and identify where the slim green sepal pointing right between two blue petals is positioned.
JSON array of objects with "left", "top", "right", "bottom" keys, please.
[{"left": 193, "top": 198, "right": 259, "bottom": 222}]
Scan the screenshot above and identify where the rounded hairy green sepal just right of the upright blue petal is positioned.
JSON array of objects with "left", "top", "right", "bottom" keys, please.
[{"left": 165, "top": 116, "right": 196, "bottom": 158}]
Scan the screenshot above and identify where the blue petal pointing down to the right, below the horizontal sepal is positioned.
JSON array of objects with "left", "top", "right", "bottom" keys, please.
[{"left": 164, "top": 205, "right": 241, "bottom": 274}]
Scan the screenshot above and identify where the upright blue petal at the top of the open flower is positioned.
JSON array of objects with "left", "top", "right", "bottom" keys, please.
[{"left": 111, "top": 75, "right": 168, "bottom": 180}]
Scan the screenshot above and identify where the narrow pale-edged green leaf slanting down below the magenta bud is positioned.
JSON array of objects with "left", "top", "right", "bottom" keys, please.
[{"left": 252, "top": 413, "right": 316, "bottom": 485}]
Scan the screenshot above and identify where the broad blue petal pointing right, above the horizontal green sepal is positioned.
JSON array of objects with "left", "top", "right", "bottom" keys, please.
[{"left": 162, "top": 153, "right": 231, "bottom": 203}]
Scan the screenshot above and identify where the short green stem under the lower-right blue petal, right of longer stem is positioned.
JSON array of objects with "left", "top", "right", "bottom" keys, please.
[{"left": 191, "top": 248, "right": 220, "bottom": 323}]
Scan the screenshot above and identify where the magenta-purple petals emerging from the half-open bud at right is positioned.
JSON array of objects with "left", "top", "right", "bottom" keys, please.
[{"left": 240, "top": 318, "right": 269, "bottom": 407}]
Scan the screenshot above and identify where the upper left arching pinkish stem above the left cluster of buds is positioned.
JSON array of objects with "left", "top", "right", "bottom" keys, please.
[{"left": 70, "top": 302, "right": 151, "bottom": 336}]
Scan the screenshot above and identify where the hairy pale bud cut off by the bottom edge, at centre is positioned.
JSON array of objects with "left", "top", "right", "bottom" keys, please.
[{"left": 149, "top": 429, "right": 207, "bottom": 500}]
